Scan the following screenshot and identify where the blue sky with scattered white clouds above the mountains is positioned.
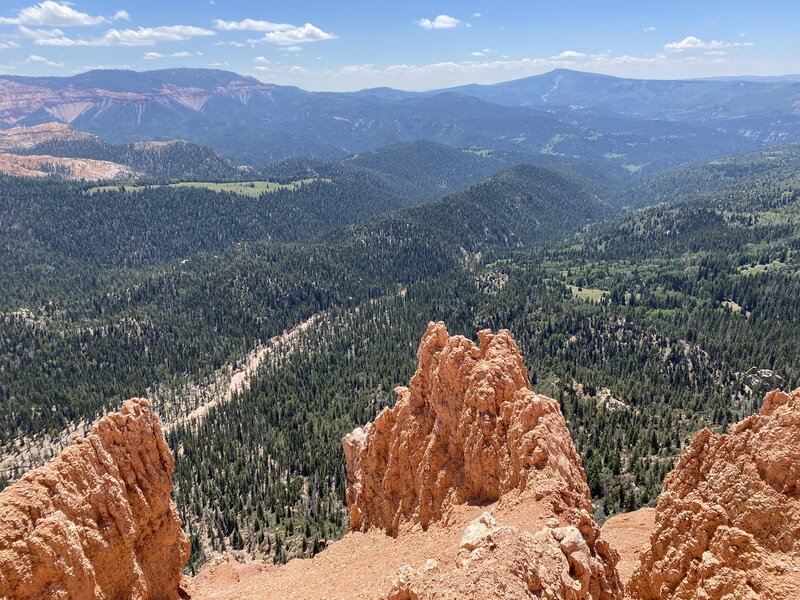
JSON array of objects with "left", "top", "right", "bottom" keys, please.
[{"left": 0, "top": 0, "right": 800, "bottom": 90}]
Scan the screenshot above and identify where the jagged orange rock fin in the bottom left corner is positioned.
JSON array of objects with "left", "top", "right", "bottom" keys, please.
[{"left": 0, "top": 400, "right": 189, "bottom": 600}]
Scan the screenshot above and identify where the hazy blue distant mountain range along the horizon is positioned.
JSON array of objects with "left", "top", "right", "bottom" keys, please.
[{"left": 0, "top": 69, "right": 800, "bottom": 173}]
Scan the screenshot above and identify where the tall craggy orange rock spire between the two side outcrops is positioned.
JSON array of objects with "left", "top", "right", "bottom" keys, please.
[{"left": 343, "top": 323, "right": 622, "bottom": 600}]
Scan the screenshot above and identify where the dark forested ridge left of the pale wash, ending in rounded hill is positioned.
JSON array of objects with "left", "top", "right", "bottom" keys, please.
[{"left": 2, "top": 166, "right": 605, "bottom": 446}]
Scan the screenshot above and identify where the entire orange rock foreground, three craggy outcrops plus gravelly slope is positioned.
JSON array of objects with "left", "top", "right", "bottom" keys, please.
[{"left": 9, "top": 323, "right": 800, "bottom": 600}]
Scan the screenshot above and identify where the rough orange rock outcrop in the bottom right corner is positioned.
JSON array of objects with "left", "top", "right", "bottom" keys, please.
[{"left": 628, "top": 389, "right": 800, "bottom": 600}]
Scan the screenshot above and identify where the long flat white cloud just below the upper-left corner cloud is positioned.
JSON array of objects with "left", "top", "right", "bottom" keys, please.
[{"left": 20, "top": 25, "right": 214, "bottom": 46}]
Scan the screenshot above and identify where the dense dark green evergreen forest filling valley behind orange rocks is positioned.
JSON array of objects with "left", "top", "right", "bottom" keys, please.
[{"left": 0, "top": 143, "right": 800, "bottom": 568}]
